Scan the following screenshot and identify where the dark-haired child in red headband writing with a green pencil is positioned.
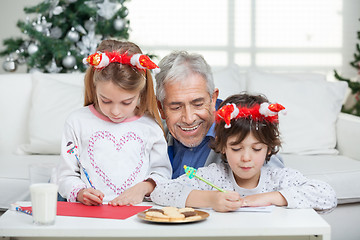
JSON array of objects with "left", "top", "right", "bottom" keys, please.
[{"left": 151, "top": 93, "right": 337, "bottom": 212}]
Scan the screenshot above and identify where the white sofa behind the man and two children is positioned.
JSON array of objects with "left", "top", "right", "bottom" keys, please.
[{"left": 0, "top": 66, "right": 360, "bottom": 239}]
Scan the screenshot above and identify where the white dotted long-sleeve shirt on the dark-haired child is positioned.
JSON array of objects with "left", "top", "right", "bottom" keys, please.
[{"left": 150, "top": 162, "right": 337, "bottom": 211}]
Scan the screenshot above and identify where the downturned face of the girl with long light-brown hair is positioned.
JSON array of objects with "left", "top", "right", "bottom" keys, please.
[{"left": 95, "top": 81, "right": 140, "bottom": 123}]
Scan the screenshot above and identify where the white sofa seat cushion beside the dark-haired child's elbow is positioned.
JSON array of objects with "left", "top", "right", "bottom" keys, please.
[{"left": 281, "top": 154, "right": 360, "bottom": 204}]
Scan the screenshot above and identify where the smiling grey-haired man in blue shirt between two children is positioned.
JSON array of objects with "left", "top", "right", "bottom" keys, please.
[{"left": 155, "top": 51, "right": 283, "bottom": 178}]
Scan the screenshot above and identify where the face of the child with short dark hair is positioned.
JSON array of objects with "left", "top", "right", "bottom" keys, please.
[{"left": 224, "top": 133, "right": 269, "bottom": 189}]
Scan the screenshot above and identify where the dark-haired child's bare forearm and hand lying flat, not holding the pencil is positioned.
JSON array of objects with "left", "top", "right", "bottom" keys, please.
[{"left": 242, "top": 192, "right": 287, "bottom": 207}]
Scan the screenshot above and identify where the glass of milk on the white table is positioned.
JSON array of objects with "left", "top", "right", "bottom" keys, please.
[{"left": 30, "top": 183, "right": 58, "bottom": 225}]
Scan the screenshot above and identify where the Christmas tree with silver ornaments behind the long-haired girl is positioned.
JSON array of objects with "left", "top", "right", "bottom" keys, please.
[{"left": 0, "top": 0, "right": 129, "bottom": 73}]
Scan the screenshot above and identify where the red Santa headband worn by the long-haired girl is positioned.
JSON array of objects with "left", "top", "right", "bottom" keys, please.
[{"left": 83, "top": 51, "right": 160, "bottom": 73}]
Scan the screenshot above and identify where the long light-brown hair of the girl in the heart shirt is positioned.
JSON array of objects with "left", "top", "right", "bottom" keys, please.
[{"left": 84, "top": 40, "right": 162, "bottom": 128}]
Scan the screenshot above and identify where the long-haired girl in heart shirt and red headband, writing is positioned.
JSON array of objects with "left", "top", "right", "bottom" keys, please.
[{"left": 58, "top": 40, "right": 172, "bottom": 205}]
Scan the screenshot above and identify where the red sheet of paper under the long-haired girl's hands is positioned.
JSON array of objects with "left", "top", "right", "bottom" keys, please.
[{"left": 21, "top": 202, "right": 151, "bottom": 219}]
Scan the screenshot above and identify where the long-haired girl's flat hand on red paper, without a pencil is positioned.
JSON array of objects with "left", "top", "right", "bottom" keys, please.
[{"left": 109, "top": 181, "right": 155, "bottom": 206}]
